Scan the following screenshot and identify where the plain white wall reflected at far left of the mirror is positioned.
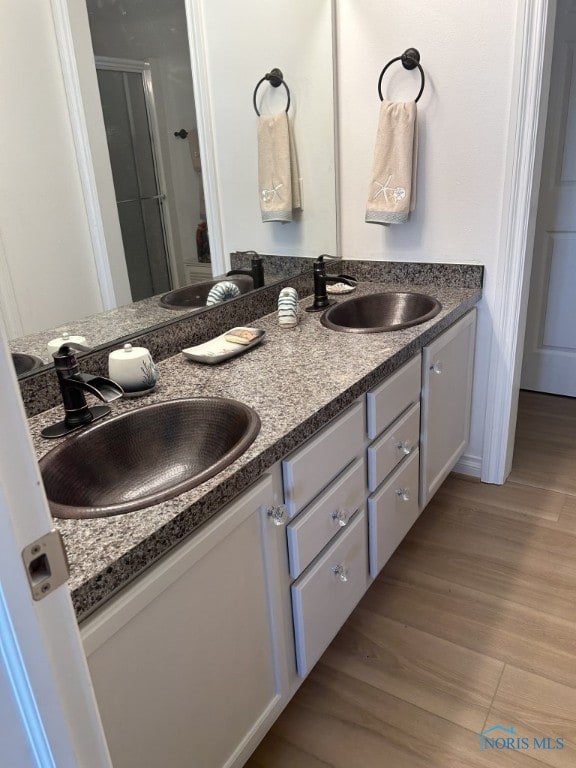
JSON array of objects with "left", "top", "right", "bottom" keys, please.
[{"left": 0, "top": 0, "right": 102, "bottom": 335}]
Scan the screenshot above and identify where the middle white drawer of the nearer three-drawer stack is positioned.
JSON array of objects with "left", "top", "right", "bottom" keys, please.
[{"left": 287, "top": 459, "right": 366, "bottom": 579}]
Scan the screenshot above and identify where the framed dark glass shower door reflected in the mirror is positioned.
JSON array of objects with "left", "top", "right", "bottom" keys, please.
[{"left": 96, "top": 57, "right": 172, "bottom": 301}]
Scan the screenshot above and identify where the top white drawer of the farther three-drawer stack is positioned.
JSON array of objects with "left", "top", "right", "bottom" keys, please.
[{"left": 366, "top": 355, "right": 420, "bottom": 440}]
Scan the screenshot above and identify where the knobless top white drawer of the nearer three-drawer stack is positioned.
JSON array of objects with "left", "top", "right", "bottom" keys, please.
[{"left": 282, "top": 401, "right": 364, "bottom": 517}]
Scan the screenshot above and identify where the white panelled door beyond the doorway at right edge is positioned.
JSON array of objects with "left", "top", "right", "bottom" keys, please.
[{"left": 521, "top": 0, "right": 576, "bottom": 397}]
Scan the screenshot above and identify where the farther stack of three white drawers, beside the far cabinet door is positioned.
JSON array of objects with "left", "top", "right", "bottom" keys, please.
[{"left": 367, "top": 355, "right": 421, "bottom": 578}]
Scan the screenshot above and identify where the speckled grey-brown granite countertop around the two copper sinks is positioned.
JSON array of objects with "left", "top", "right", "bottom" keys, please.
[{"left": 29, "top": 282, "right": 481, "bottom": 620}]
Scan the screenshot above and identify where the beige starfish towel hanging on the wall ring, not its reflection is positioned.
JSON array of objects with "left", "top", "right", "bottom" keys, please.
[{"left": 366, "top": 101, "right": 418, "bottom": 224}]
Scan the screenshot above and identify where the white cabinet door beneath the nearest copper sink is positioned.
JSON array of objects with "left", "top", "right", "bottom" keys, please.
[{"left": 82, "top": 477, "right": 283, "bottom": 768}]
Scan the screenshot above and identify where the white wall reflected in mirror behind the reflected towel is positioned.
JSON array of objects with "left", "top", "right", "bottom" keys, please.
[{"left": 202, "top": 0, "right": 336, "bottom": 256}]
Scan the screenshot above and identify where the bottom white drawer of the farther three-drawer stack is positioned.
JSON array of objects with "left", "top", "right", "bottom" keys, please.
[{"left": 368, "top": 451, "right": 419, "bottom": 577}]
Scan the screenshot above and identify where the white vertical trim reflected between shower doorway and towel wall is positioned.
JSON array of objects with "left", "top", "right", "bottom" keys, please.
[{"left": 184, "top": 0, "right": 230, "bottom": 275}]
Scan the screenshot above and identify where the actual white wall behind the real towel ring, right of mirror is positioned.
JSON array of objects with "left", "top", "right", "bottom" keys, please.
[{"left": 338, "top": 0, "right": 521, "bottom": 472}]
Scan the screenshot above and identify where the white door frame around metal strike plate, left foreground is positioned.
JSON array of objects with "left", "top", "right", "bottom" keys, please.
[{"left": 0, "top": 334, "right": 111, "bottom": 768}]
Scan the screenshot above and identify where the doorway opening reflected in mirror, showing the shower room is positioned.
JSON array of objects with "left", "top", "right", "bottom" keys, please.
[{"left": 86, "top": 0, "right": 212, "bottom": 301}]
